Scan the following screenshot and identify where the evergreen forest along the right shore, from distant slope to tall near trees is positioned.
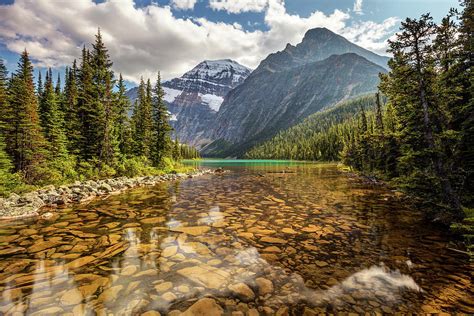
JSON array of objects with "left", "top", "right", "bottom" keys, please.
[{"left": 247, "top": 0, "right": 474, "bottom": 223}]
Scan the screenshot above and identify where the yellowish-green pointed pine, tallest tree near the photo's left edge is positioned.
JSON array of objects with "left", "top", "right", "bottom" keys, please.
[{"left": 7, "top": 50, "right": 47, "bottom": 183}]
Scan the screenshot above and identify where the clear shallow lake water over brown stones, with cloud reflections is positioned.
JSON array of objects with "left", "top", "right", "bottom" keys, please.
[{"left": 0, "top": 162, "right": 474, "bottom": 315}]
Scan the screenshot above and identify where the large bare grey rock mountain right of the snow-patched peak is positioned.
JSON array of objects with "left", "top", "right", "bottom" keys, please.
[{"left": 202, "top": 28, "right": 388, "bottom": 157}]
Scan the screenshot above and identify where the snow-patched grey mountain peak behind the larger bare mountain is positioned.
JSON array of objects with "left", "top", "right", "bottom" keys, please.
[{"left": 127, "top": 59, "right": 251, "bottom": 147}]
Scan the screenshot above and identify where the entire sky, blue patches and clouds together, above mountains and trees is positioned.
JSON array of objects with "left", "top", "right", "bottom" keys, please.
[{"left": 0, "top": 0, "right": 459, "bottom": 85}]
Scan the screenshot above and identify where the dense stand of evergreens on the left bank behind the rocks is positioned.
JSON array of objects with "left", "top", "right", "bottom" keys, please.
[{"left": 0, "top": 31, "right": 198, "bottom": 195}]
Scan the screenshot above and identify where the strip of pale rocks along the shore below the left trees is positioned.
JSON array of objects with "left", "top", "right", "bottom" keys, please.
[{"left": 0, "top": 169, "right": 215, "bottom": 220}]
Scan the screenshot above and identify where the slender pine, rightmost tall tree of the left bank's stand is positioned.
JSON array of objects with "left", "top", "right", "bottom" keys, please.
[{"left": 151, "top": 73, "right": 172, "bottom": 166}]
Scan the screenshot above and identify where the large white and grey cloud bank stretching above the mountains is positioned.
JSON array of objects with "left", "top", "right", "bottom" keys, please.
[{"left": 0, "top": 0, "right": 396, "bottom": 82}]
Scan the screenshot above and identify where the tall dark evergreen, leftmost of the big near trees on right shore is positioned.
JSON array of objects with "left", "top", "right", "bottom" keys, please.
[{"left": 382, "top": 14, "right": 462, "bottom": 221}]
